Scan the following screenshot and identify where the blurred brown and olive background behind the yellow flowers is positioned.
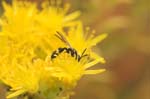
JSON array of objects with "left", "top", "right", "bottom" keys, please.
[{"left": 0, "top": 0, "right": 150, "bottom": 99}]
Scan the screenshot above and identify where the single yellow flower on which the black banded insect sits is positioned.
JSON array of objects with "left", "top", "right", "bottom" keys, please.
[{"left": 44, "top": 22, "right": 107, "bottom": 85}]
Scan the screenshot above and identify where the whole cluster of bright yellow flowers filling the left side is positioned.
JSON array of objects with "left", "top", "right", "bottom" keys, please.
[{"left": 0, "top": 0, "right": 107, "bottom": 99}]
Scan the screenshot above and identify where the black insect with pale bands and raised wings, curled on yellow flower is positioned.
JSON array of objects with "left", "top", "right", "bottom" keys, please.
[{"left": 51, "top": 32, "right": 88, "bottom": 62}]
